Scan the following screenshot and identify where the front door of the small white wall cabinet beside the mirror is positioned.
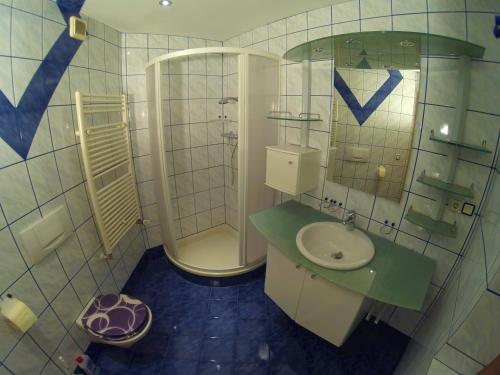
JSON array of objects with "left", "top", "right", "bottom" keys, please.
[{"left": 266, "top": 150, "right": 299, "bottom": 195}]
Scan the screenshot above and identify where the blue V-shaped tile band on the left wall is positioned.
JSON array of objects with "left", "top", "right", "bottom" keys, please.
[{"left": 0, "top": 0, "right": 85, "bottom": 159}]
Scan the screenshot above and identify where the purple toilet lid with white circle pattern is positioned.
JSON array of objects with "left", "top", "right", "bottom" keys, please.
[{"left": 82, "top": 294, "right": 148, "bottom": 340}]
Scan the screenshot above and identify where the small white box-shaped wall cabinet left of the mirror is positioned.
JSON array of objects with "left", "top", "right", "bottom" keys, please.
[{"left": 266, "top": 144, "right": 321, "bottom": 195}]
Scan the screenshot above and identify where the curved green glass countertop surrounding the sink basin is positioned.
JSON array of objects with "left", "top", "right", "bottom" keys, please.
[{"left": 250, "top": 201, "right": 435, "bottom": 311}]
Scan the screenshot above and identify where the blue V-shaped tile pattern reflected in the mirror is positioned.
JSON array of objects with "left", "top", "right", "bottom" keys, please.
[{"left": 333, "top": 69, "right": 403, "bottom": 126}]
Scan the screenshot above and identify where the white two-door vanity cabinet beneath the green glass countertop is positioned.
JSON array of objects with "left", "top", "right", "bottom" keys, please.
[{"left": 264, "top": 245, "right": 366, "bottom": 346}]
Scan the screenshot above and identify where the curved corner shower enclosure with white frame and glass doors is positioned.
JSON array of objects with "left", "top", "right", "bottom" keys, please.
[{"left": 146, "top": 47, "right": 280, "bottom": 276}]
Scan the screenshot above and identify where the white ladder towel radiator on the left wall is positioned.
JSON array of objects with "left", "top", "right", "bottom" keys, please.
[{"left": 75, "top": 91, "right": 140, "bottom": 257}]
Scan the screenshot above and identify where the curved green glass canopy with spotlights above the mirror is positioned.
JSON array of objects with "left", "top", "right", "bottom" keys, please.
[{"left": 283, "top": 31, "right": 484, "bottom": 69}]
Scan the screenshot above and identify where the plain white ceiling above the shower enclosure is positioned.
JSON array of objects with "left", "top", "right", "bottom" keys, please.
[{"left": 82, "top": 0, "right": 347, "bottom": 40}]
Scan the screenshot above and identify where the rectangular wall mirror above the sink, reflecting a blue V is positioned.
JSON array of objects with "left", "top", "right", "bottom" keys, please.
[{"left": 327, "top": 67, "right": 419, "bottom": 200}]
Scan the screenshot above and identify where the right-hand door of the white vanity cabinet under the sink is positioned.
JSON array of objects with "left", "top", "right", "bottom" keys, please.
[{"left": 295, "top": 271, "right": 364, "bottom": 346}]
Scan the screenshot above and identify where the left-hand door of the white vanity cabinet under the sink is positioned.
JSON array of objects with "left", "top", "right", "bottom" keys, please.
[{"left": 264, "top": 245, "right": 305, "bottom": 319}]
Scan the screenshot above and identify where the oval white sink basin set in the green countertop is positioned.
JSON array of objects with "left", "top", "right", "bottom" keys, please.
[{"left": 296, "top": 221, "right": 375, "bottom": 270}]
